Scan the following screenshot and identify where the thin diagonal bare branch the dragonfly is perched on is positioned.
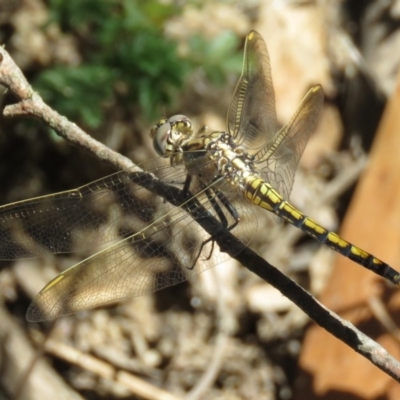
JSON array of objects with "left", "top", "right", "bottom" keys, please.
[{"left": 0, "top": 44, "right": 400, "bottom": 382}]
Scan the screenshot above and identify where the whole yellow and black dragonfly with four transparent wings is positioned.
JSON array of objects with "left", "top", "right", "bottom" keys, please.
[{"left": 0, "top": 31, "right": 400, "bottom": 321}]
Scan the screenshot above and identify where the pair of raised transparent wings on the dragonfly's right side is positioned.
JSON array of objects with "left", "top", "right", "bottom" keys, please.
[{"left": 228, "top": 31, "right": 323, "bottom": 200}]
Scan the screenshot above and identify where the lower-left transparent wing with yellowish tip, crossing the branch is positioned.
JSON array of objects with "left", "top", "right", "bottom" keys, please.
[{"left": 27, "top": 169, "right": 256, "bottom": 321}]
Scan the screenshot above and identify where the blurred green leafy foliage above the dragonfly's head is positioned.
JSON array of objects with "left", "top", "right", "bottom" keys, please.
[{"left": 34, "top": 0, "right": 241, "bottom": 128}]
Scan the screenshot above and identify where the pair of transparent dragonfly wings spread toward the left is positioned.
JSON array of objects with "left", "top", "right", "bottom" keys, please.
[{"left": 0, "top": 155, "right": 256, "bottom": 321}]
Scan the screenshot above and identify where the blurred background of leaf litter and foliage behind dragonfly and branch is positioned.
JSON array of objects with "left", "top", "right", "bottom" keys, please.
[{"left": 0, "top": 0, "right": 400, "bottom": 399}]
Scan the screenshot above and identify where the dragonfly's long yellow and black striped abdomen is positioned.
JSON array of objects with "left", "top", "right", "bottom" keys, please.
[{"left": 244, "top": 176, "right": 400, "bottom": 286}]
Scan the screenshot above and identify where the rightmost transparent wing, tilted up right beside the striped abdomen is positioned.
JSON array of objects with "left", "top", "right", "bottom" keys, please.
[{"left": 256, "top": 85, "right": 324, "bottom": 200}]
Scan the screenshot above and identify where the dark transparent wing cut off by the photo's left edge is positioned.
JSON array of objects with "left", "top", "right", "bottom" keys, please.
[{"left": 0, "top": 159, "right": 190, "bottom": 260}]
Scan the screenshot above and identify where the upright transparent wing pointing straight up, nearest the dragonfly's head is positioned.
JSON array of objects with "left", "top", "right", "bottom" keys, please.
[{"left": 227, "top": 31, "right": 277, "bottom": 152}]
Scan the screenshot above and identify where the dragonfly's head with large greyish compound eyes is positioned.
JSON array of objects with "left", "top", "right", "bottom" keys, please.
[{"left": 150, "top": 115, "right": 193, "bottom": 157}]
